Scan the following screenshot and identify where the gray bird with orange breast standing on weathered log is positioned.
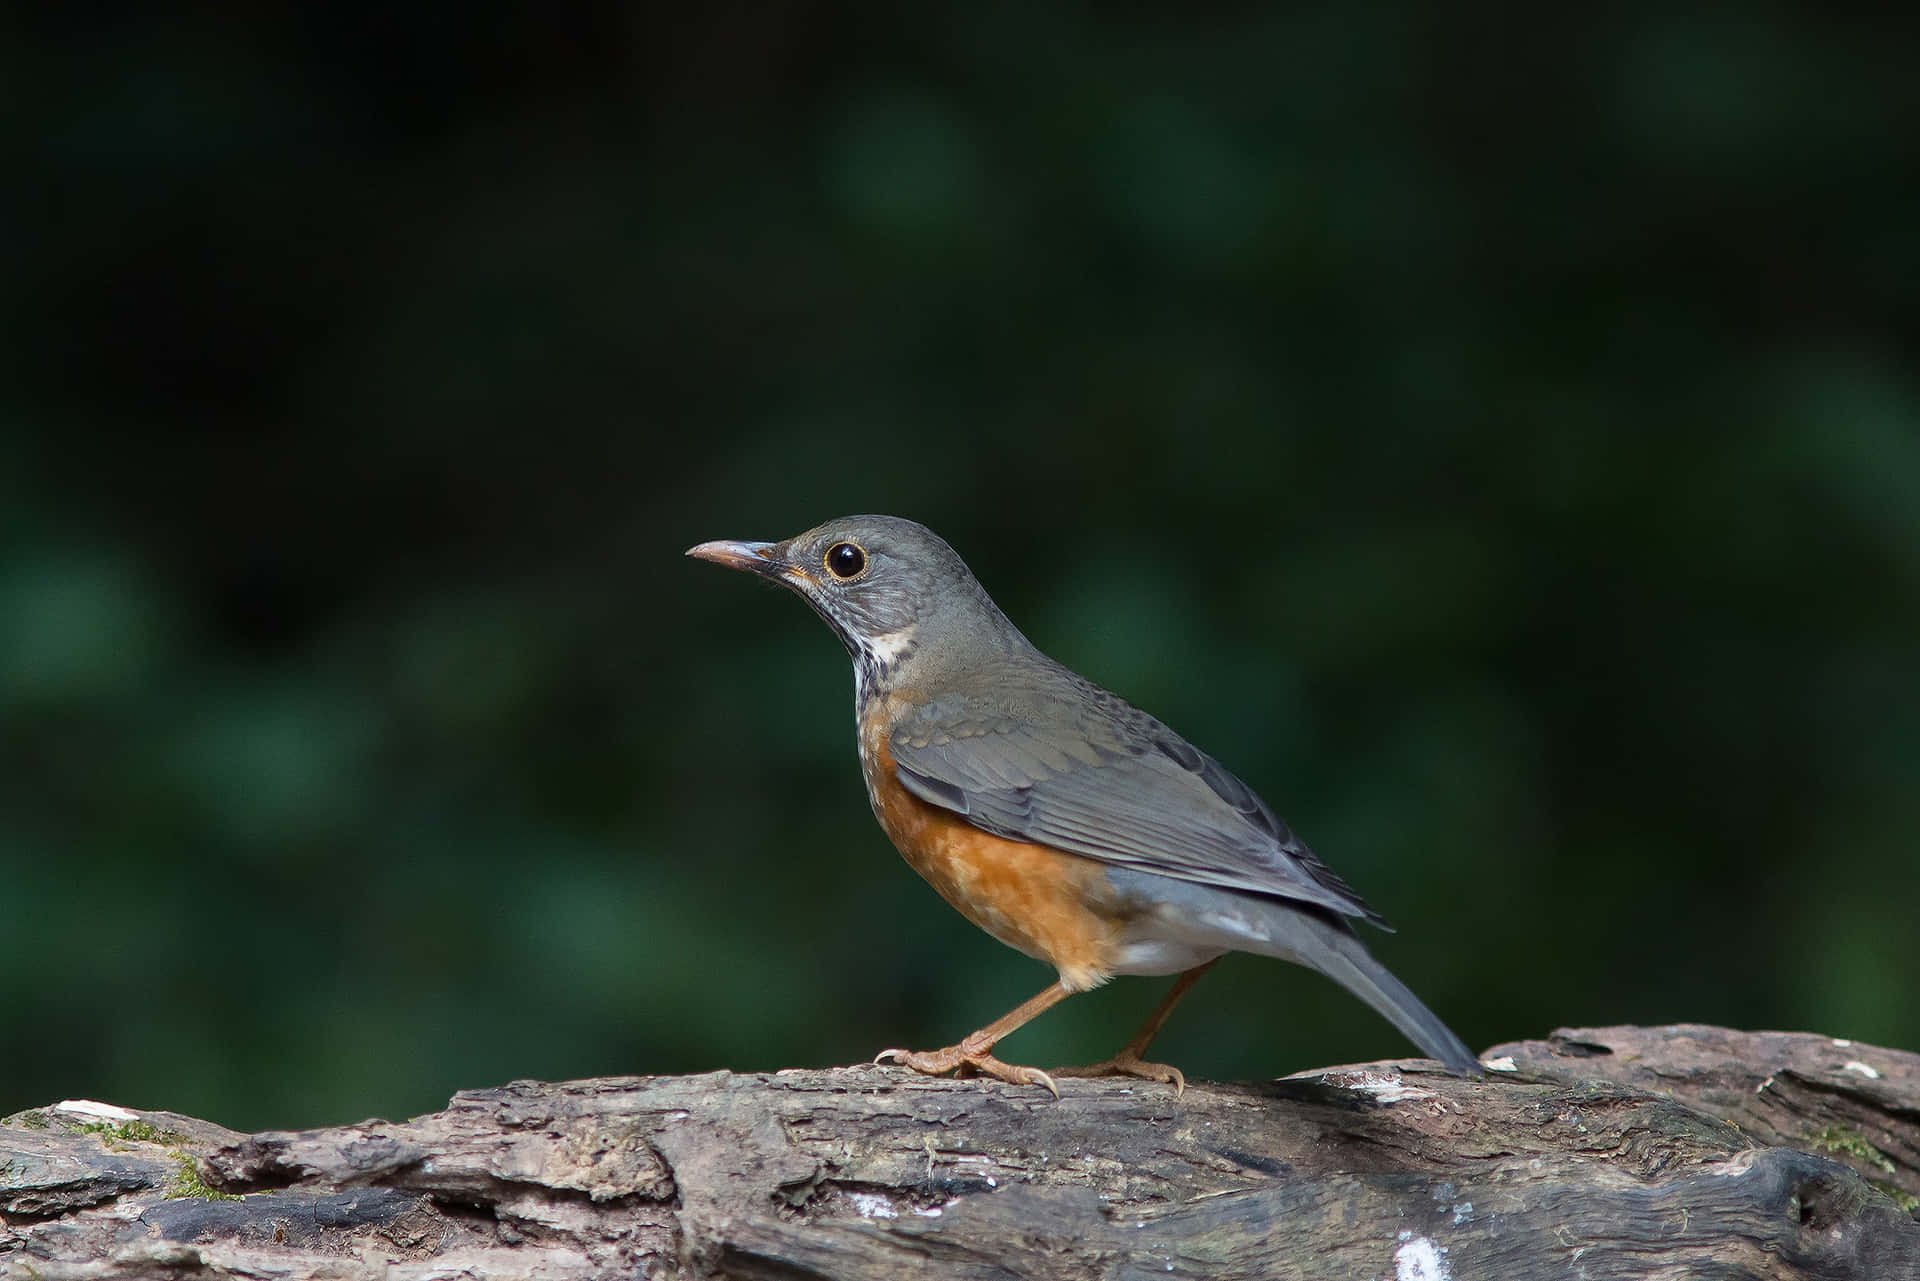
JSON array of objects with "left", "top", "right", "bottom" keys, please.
[{"left": 687, "top": 515, "right": 1478, "bottom": 1097}]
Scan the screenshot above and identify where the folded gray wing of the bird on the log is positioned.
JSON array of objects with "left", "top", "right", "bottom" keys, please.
[{"left": 889, "top": 684, "right": 1384, "bottom": 924}]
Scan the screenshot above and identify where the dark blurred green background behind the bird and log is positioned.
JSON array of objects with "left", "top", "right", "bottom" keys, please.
[{"left": 0, "top": 2, "right": 1920, "bottom": 1127}]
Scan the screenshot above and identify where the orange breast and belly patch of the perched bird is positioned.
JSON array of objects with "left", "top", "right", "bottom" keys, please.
[{"left": 860, "top": 701, "right": 1125, "bottom": 991}]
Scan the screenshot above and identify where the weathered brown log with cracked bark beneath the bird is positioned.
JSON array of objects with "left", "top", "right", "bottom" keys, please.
[{"left": 0, "top": 1026, "right": 1920, "bottom": 1281}]
